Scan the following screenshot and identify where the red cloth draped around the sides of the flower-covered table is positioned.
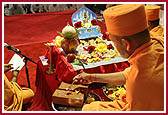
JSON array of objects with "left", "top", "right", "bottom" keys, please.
[{"left": 29, "top": 47, "right": 129, "bottom": 111}]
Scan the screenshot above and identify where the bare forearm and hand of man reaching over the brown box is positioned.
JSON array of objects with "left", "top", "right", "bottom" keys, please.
[{"left": 73, "top": 72, "right": 126, "bottom": 85}]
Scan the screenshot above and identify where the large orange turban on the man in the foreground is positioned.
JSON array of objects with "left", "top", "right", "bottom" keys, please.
[{"left": 103, "top": 4, "right": 147, "bottom": 36}]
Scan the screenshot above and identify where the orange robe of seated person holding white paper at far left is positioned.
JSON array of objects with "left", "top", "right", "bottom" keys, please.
[{"left": 4, "top": 75, "right": 34, "bottom": 111}]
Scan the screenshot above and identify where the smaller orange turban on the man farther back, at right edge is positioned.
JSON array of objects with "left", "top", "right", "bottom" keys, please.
[{"left": 145, "top": 6, "right": 160, "bottom": 21}]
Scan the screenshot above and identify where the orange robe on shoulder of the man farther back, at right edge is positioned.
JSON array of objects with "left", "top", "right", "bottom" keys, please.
[{"left": 150, "top": 25, "right": 164, "bottom": 39}]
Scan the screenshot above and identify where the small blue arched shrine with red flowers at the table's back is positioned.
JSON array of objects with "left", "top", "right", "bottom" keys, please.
[{"left": 72, "top": 6, "right": 102, "bottom": 39}]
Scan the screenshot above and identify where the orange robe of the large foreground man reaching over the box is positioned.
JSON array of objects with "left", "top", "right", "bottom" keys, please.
[{"left": 82, "top": 38, "right": 164, "bottom": 111}]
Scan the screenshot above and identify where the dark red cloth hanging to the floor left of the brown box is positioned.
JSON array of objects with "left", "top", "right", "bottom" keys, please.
[{"left": 28, "top": 61, "right": 60, "bottom": 111}]
